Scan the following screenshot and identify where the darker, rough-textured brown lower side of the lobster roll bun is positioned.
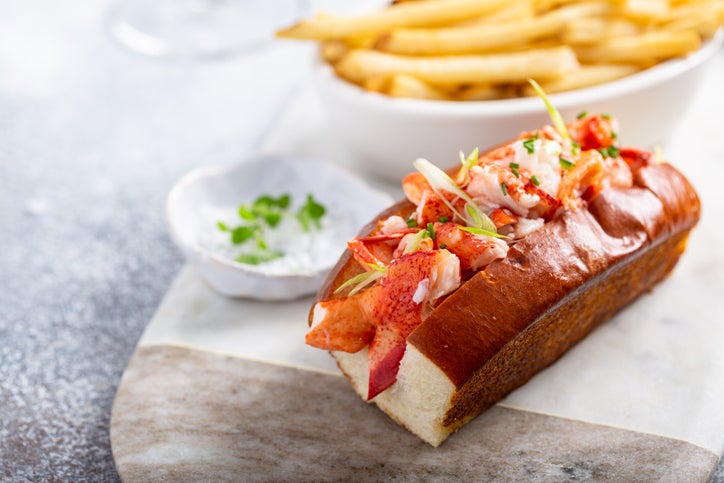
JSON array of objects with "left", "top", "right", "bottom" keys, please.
[{"left": 443, "top": 223, "right": 688, "bottom": 430}]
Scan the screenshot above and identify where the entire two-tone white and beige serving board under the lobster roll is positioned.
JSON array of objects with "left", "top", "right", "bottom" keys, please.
[{"left": 111, "top": 62, "right": 724, "bottom": 481}]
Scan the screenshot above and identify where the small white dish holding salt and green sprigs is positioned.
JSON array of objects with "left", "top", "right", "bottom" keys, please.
[{"left": 166, "top": 157, "right": 393, "bottom": 300}]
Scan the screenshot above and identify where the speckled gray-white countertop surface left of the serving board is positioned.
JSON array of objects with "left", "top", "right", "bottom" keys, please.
[{"left": 0, "top": 0, "right": 724, "bottom": 482}]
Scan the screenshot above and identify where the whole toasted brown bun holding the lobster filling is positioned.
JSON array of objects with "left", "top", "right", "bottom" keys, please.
[{"left": 317, "top": 164, "right": 700, "bottom": 446}]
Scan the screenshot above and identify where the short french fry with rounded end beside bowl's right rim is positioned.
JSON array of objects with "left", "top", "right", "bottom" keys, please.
[{"left": 576, "top": 30, "right": 701, "bottom": 65}]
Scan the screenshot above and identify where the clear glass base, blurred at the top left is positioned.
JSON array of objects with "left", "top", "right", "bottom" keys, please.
[{"left": 110, "top": 0, "right": 306, "bottom": 58}]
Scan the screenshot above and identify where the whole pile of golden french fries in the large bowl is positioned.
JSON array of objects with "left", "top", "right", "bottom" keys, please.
[{"left": 277, "top": 0, "right": 724, "bottom": 101}]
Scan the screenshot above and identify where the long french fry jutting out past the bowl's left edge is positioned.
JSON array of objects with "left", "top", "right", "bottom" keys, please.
[{"left": 277, "top": 0, "right": 508, "bottom": 40}]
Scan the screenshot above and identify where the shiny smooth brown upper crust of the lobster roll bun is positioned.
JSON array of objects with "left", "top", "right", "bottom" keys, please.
[{"left": 408, "top": 164, "right": 700, "bottom": 387}]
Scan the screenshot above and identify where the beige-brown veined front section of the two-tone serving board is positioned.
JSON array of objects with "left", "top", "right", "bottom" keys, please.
[{"left": 111, "top": 345, "right": 718, "bottom": 483}]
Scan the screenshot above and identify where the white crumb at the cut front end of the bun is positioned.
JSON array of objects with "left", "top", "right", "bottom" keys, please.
[{"left": 332, "top": 344, "right": 455, "bottom": 446}]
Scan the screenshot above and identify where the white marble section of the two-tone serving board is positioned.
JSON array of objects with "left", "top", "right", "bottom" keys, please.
[{"left": 141, "top": 48, "right": 724, "bottom": 454}]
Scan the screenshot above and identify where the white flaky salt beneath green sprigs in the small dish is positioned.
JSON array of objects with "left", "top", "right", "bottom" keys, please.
[{"left": 198, "top": 201, "right": 356, "bottom": 275}]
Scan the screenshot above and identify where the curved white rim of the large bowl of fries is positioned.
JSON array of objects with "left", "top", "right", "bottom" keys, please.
[{"left": 320, "top": 28, "right": 724, "bottom": 117}]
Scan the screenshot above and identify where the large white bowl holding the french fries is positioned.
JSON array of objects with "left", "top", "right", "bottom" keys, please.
[{"left": 317, "top": 29, "right": 724, "bottom": 180}]
